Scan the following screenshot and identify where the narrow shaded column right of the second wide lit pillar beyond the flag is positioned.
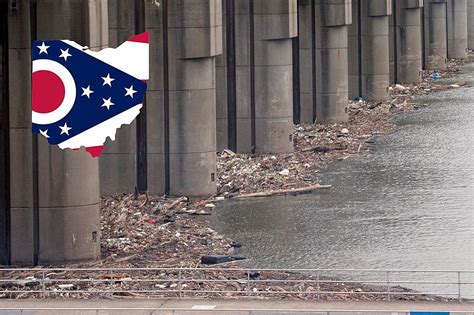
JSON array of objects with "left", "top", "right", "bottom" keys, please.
[{"left": 298, "top": 0, "right": 316, "bottom": 124}]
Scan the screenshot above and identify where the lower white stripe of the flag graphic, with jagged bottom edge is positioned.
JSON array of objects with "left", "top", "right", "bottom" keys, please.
[{"left": 59, "top": 104, "right": 143, "bottom": 149}]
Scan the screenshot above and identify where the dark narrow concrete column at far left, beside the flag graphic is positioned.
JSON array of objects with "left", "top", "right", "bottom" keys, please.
[{"left": 6, "top": 0, "right": 34, "bottom": 264}]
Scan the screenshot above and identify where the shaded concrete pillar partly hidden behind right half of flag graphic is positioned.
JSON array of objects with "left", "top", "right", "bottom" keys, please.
[{"left": 99, "top": 0, "right": 137, "bottom": 196}]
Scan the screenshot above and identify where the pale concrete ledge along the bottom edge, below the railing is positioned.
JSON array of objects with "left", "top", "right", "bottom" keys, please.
[{"left": 0, "top": 299, "right": 474, "bottom": 315}]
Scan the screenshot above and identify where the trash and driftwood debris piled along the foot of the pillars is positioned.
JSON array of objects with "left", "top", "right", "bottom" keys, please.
[{"left": 95, "top": 56, "right": 466, "bottom": 267}]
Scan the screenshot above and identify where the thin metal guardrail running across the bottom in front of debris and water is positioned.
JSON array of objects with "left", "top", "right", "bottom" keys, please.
[{"left": 0, "top": 268, "right": 474, "bottom": 300}]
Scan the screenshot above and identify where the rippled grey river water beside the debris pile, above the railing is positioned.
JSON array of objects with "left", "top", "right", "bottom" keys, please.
[{"left": 214, "top": 64, "right": 474, "bottom": 295}]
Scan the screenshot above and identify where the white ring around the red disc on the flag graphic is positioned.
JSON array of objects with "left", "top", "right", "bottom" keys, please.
[{"left": 32, "top": 59, "right": 76, "bottom": 125}]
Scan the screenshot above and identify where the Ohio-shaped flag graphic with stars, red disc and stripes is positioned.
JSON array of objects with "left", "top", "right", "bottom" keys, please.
[{"left": 32, "top": 33, "right": 149, "bottom": 157}]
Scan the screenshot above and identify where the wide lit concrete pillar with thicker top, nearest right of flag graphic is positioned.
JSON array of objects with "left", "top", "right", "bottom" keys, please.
[{"left": 168, "top": 0, "right": 222, "bottom": 195}]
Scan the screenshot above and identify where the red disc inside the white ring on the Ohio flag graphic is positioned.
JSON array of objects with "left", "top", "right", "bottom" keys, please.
[{"left": 31, "top": 70, "right": 65, "bottom": 114}]
